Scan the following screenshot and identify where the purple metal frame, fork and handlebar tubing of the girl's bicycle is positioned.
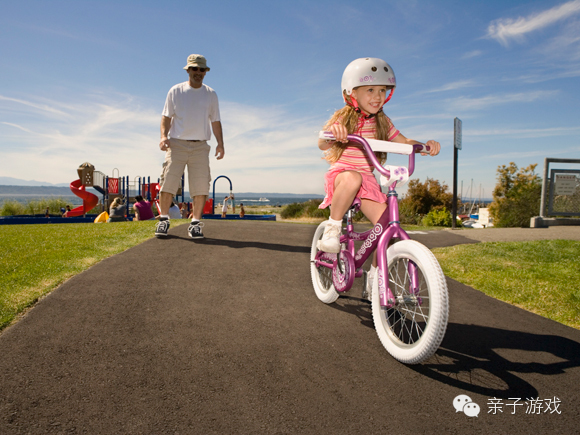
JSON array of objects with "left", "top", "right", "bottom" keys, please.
[{"left": 316, "top": 133, "right": 429, "bottom": 308}]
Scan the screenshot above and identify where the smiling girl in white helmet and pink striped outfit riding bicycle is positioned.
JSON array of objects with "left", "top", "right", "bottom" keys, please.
[{"left": 318, "top": 57, "right": 441, "bottom": 255}]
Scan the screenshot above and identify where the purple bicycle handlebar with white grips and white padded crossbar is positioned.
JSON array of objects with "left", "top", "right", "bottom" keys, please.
[{"left": 318, "top": 131, "right": 430, "bottom": 178}]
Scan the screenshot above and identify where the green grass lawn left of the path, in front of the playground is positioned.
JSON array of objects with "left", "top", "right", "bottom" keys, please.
[{"left": 0, "top": 221, "right": 185, "bottom": 329}]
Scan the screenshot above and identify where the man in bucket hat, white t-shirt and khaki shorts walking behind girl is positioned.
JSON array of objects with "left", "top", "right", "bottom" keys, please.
[{"left": 155, "top": 54, "right": 225, "bottom": 239}]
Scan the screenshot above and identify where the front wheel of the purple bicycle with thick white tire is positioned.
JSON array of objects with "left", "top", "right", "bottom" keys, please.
[{"left": 372, "top": 240, "right": 449, "bottom": 364}]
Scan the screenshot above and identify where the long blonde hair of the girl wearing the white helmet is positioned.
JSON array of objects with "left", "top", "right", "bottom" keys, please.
[{"left": 324, "top": 96, "right": 391, "bottom": 165}]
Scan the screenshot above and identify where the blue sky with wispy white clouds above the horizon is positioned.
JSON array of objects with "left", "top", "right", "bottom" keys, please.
[{"left": 0, "top": 0, "right": 580, "bottom": 197}]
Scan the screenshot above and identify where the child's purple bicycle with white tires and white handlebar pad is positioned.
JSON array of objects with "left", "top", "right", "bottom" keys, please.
[{"left": 310, "top": 132, "right": 449, "bottom": 364}]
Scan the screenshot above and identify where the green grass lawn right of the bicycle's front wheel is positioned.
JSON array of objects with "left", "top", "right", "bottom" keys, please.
[{"left": 433, "top": 240, "right": 580, "bottom": 329}]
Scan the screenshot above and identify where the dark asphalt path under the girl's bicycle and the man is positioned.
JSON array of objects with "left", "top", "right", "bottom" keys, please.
[{"left": 0, "top": 221, "right": 580, "bottom": 435}]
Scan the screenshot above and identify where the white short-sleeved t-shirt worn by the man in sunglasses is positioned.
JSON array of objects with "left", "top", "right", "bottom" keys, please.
[{"left": 162, "top": 82, "right": 220, "bottom": 140}]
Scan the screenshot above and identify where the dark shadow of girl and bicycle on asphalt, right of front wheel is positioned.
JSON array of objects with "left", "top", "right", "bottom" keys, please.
[{"left": 410, "top": 323, "right": 580, "bottom": 398}]
